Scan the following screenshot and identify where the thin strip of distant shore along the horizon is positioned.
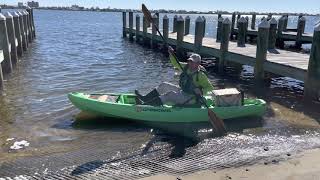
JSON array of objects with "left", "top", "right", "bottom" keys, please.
[{"left": 1, "top": 6, "right": 320, "bottom": 16}]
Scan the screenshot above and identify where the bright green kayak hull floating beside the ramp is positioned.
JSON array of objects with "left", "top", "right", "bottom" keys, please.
[{"left": 68, "top": 92, "right": 266, "bottom": 123}]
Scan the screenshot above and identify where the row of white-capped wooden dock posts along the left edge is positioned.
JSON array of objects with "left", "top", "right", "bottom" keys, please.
[{"left": 0, "top": 7, "right": 36, "bottom": 90}]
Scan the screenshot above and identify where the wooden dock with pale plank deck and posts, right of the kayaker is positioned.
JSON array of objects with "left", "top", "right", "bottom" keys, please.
[{"left": 123, "top": 12, "right": 320, "bottom": 100}]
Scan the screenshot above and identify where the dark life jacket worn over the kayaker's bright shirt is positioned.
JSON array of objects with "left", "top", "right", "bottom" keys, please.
[{"left": 179, "top": 64, "right": 208, "bottom": 94}]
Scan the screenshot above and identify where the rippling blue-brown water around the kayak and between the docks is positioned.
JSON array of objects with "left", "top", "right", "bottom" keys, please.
[{"left": 0, "top": 10, "right": 320, "bottom": 176}]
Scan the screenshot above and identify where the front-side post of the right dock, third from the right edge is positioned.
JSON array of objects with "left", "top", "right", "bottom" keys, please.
[{"left": 219, "top": 18, "right": 231, "bottom": 74}]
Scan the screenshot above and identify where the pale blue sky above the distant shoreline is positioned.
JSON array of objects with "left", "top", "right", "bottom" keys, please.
[{"left": 0, "top": 0, "right": 320, "bottom": 14}]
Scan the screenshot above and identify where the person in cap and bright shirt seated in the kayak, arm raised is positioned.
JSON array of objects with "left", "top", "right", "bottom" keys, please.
[{"left": 135, "top": 47, "right": 213, "bottom": 106}]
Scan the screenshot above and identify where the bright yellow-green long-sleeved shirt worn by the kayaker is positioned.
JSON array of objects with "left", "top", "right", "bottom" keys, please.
[{"left": 170, "top": 54, "right": 213, "bottom": 95}]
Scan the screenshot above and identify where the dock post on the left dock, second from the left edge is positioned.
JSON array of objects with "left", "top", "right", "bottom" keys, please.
[{"left": 5, "top": 12, "right": 18, "bottom": 66}]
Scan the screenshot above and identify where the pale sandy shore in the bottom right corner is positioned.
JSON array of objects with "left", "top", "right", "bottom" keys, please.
[{"left": 143, "top": 148, "right": 320, "bottom": 180}]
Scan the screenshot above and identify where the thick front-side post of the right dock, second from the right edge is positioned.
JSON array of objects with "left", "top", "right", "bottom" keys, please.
[{"left": 254, "top": 19, "right": 270, "bottom": 82}]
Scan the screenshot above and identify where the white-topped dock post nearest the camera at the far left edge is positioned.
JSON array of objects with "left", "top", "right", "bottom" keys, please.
[{"left": 0, "top": 14, "right": 12, "bottom": 73}]
